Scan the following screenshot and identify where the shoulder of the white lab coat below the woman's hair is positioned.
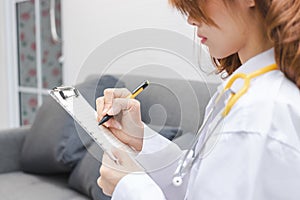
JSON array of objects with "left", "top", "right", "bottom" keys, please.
[{"left": 223, "top": 71, "right": 300, "bottom": 149}]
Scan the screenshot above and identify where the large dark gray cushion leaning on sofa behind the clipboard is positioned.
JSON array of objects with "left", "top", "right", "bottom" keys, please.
[{"left": 21, "top": 76, "right": 125, "bottom": 174}]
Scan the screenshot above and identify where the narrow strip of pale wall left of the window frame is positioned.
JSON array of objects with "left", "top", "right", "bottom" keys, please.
[{"left": 0, "top": 1, "right": 9, "bottom": 129}]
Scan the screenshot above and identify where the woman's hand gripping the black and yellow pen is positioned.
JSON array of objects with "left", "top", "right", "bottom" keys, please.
[{"left": 96, "top": 88, "right": 144, "bottom": 151}]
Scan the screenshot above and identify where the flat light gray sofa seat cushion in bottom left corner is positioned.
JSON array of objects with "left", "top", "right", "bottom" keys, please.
[{"left": 0, "top": 172, "right": 88, "bottom": 200}]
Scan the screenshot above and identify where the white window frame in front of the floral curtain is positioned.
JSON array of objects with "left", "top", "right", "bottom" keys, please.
[{"left": 4, "top": 0, "right": 56, "bottom": 128}]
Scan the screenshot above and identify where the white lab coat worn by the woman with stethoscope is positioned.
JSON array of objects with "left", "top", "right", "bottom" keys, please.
[{"left": 112, "top": 49, "right": 300, "bottom": 200}]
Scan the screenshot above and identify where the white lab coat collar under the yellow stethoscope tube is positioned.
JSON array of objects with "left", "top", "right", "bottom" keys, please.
[{"left": 222, "top": 48, "right": 275, "bottom": 93}]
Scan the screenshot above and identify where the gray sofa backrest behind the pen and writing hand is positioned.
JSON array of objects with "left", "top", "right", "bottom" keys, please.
[{"left": 87, "top": 74, "right": 218, "bottom": 133}]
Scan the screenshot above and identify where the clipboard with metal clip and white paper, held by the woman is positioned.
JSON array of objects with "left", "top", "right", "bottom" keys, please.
[{"left": 49, "top": 86, "right": 138, "bottom": 163}]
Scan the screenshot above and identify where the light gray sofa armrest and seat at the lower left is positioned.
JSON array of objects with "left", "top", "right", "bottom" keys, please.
[{"left": 0, "top": 126, "right": 89, "bottom": 200}]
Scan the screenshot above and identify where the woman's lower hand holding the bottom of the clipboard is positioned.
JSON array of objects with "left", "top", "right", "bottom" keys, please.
[{"left": 97, "top": 150, "right": 143, "bottom": 196}]
